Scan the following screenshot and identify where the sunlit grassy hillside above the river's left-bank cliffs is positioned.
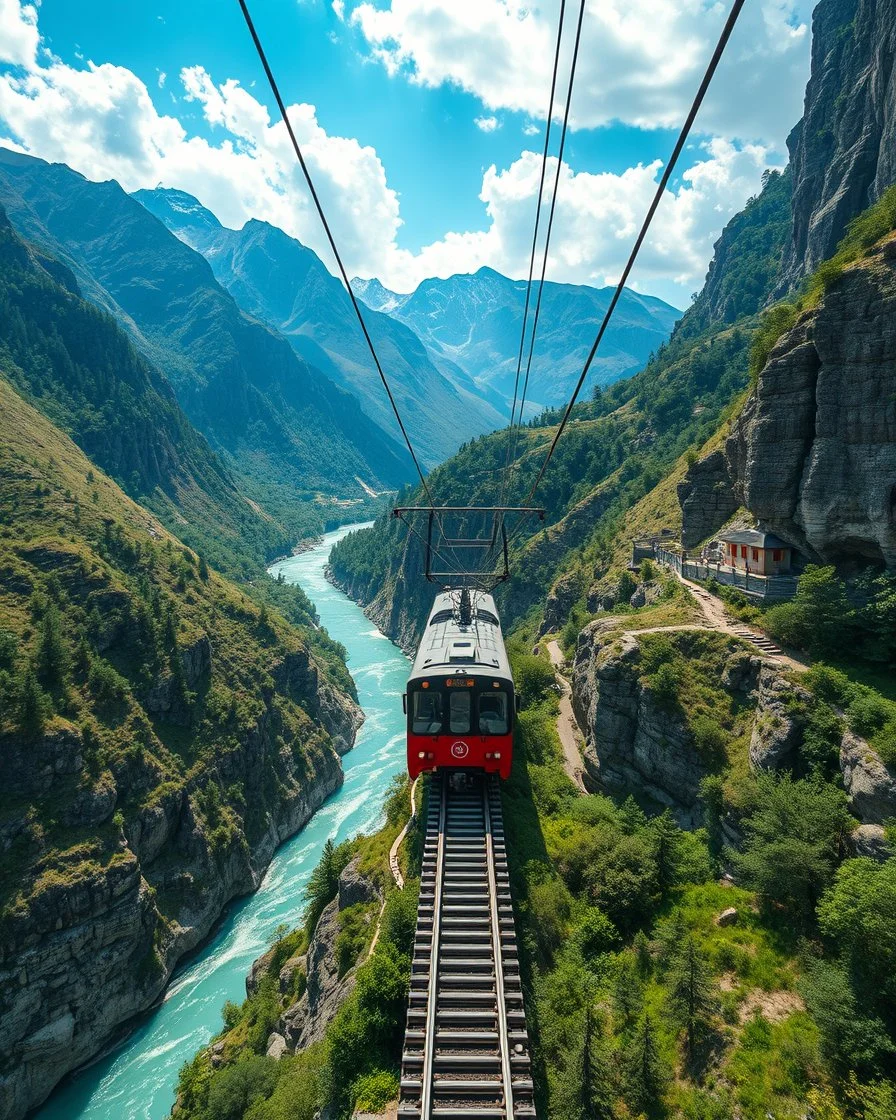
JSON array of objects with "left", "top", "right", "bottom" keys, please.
[{"left": 0, "top": 379, "right": 356, "bottom": 948}]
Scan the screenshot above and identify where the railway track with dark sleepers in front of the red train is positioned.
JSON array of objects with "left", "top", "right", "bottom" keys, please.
[{"left": 399, "top": 773, "right": 535, "bottom": 1120}]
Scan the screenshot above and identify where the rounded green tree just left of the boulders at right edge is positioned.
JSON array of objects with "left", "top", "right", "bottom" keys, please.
[{"left": 732, "top": 774, "right": 851, "bottom": 925}]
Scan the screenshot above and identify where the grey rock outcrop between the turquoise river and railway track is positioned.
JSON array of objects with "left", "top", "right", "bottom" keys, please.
[{"left": 277, "top": 859, "right": 381, "bottom": 1057}]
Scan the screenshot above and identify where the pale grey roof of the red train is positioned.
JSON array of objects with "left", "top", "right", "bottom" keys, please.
[{"left": 411, "top": 591, "right": 511, "bottom": 679}]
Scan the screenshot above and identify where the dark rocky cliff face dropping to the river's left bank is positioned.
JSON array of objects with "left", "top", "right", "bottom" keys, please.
[{"left": 0, "top": 653, "right": 360, "bottom": 1120}]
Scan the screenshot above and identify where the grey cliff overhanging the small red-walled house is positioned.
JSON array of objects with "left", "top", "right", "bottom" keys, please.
[{"left": 679, "top": 240, "right": 896, "bottom": 567}]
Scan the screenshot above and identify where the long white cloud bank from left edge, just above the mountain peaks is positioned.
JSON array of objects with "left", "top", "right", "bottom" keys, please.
[{"left": 0, "top": 0, "right": 792, "bottom": 300}]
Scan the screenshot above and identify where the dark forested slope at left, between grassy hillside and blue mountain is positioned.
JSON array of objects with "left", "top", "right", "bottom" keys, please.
[{"left": 0, "top": 207, "right": 288, "bottom": 573}]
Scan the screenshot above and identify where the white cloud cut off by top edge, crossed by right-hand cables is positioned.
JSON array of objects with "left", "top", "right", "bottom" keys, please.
[{"left": 351, "top": 0, "right": 812, "bottom": 146}]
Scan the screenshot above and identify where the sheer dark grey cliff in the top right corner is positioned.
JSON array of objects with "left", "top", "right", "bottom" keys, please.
[{"left": 781, "top": 0, "right": 896, "bottom": 291}]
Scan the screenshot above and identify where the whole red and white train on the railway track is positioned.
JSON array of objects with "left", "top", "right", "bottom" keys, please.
[{"left": 404, "top": 589, "right": 516, "bottom": 778}]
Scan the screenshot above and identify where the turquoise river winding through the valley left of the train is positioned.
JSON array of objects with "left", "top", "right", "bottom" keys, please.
[{"left": 37, "top": 526, "right": 409, "bottom": 1120}]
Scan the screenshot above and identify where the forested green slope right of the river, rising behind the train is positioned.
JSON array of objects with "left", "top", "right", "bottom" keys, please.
[{"left": 330, "top": 174, "right": 790, "bottom": 644}]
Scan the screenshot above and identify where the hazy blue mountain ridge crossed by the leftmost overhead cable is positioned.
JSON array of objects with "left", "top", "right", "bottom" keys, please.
[{"left": 133, "top": 188, "right": 502, "bottom": 466}]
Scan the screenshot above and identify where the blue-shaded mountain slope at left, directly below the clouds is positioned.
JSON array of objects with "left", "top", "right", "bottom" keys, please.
[{"left": 0, "top": 150, "right": 410, "bottom": 531}]
